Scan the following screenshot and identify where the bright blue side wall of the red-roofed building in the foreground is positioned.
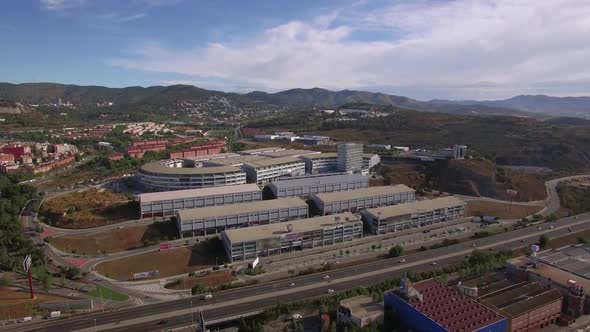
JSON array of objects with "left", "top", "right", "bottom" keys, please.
[{"left": 383, "top": 292, "right": 447, "bottom": 332}]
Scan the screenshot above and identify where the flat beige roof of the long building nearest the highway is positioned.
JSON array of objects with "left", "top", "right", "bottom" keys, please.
[{"left": 224, "top": 212, "right": 362, "bottom": 243}]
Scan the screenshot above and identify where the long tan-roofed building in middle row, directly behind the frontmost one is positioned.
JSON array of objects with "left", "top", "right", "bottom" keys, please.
[{"left": 176, "top": 197, "right": 309, "bottom": 236}]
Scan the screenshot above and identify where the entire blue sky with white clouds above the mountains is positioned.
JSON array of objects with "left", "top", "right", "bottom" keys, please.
[{"left": 0, "top": 0, "right": 590, "bottom": 100}]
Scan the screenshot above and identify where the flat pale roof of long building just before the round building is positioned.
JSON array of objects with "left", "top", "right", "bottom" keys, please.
[{"left": 139, "top": 183, "right": 260, "bottom": 203}]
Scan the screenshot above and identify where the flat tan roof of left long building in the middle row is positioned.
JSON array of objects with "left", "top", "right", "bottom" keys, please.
[{"left": 177, "top": 197, "right": 307, "bottom": 220}]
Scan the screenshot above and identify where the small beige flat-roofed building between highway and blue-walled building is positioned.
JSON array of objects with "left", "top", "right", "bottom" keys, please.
[{"left": 336, "top": 295, "right": 384, "bottom": 328}]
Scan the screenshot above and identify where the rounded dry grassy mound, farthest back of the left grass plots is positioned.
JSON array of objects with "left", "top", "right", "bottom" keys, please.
[{"left": 40, "top": 188, "right": 138, "bottom": 228}]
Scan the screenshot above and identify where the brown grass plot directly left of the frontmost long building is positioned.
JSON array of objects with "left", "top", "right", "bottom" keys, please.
[{"left": 96, "top": 239, "right": 225, "bottom": 280}]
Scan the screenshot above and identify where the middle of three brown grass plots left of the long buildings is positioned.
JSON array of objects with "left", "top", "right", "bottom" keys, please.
[{"left": 49, "top": 222, "right": 178, "bottom": 255}]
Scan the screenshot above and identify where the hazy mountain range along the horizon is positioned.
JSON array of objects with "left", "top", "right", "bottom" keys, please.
[{"left": 0, "top": 83, "right": 590, "bottom": 118}]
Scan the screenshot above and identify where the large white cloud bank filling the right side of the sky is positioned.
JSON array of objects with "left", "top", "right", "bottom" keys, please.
[{"left": 110, "top": 0, "right": 590, "bottom": 98}]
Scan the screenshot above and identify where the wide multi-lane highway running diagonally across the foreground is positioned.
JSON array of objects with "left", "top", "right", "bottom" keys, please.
[{"left": 10, "top": 214, "right": 590, "bottom": 332}]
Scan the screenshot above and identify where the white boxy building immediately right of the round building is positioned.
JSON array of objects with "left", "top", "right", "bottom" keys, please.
[{"left": 242, "top": 157, "right": 305, "bottom": 184}]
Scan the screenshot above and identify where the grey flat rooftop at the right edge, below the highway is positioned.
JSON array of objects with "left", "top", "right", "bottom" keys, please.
[{"left": 537, "top": 244, "right": 590, "bottom": 279}]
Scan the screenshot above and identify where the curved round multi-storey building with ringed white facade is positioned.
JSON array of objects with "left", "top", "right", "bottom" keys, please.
[{"left": 138, "top": 159, "right": 246, "bottom": 191}]
